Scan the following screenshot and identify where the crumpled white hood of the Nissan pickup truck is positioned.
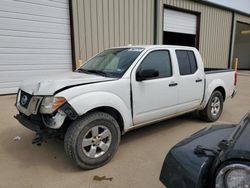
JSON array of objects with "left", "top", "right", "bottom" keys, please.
[{"left": 20, "top": 72, "right": 117, "bottom": 95}]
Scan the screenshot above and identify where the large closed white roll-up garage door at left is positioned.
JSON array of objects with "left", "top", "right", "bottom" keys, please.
[{"left": 0, "top": 0, "right": 72, "bottom": 94}]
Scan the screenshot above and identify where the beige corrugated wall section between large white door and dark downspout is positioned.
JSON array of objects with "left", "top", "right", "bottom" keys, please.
[{"left": 72, "top": 0, "right": 154, "bottom": 67}]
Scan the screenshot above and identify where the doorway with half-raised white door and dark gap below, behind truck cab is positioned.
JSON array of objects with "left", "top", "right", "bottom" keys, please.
[{"left": 163, "top": 9, "right": 199, "bottom": 48}]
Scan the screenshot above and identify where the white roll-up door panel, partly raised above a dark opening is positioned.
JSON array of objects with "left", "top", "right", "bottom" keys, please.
[{"left": 164, "top": 9, "right": 197, "bottom": 35}]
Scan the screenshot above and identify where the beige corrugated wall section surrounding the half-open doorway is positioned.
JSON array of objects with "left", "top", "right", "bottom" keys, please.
[{"left": 157, "top": 0, "right": 232, "bottom": 68}]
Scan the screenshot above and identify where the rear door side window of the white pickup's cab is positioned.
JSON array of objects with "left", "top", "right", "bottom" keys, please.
[{"left": 175, "top": 50, "right": 198, "bottom": 76}]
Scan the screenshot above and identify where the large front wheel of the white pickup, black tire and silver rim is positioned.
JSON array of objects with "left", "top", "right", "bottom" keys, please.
[{"left": 64, "top": 112, "right": 121, "bottom": 169}]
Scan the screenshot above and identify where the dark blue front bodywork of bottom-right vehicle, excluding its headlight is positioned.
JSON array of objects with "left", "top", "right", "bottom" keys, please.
[{"left": 160, "top": 113, "right": 250, "bottom": 188}]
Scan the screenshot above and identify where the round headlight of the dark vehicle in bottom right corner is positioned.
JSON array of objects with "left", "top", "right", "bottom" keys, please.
[{"left": 215, "top": 164, "right": 250, "bottom": 188}]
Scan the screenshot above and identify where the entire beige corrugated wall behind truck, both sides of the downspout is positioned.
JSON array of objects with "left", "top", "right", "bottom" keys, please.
[{"left": 72, "top": 0, "right": 236, "bottom": 67}]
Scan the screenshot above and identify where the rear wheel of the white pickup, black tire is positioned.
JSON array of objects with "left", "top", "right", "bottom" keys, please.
[{"left": 200, "top": 90, "right": 224, "bottom": 122}]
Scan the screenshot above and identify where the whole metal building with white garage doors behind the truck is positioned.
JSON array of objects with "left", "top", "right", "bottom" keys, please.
[{"left": 0, "top": 0, "right": 250, "bottom": 94}]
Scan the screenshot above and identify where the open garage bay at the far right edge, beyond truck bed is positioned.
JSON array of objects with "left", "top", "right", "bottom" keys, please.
[{"left": 233, "top": 22, "right": 250, "bottom": 70}]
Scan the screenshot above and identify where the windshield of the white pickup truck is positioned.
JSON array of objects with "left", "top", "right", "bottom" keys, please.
[{"left": 77, "top": 48, "right": 144, "bottom": 78}]
